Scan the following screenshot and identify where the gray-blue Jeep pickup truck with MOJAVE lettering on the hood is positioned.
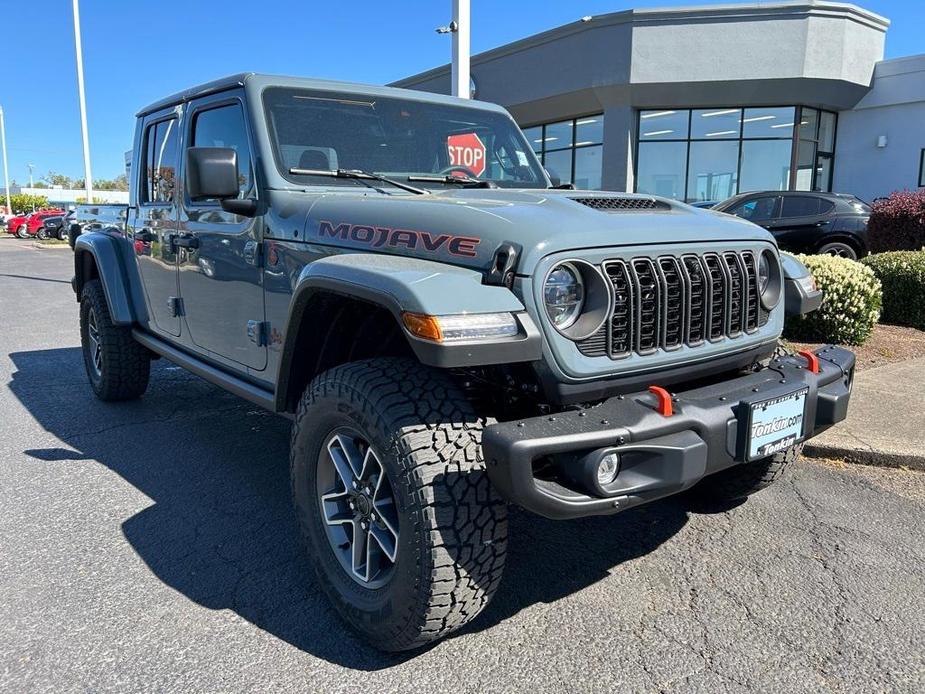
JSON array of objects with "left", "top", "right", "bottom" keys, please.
[{"left": 73, "top": 74, "right": 854, "bottom": 650}]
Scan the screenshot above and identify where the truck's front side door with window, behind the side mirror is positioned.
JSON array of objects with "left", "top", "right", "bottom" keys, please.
[{"left": 177, "top": 92, "right": 267, "bottom": 371}]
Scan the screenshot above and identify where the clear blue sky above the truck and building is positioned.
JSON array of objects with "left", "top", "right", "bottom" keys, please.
[{"left": 0, "top": 0, "right": 925, "bottom": 186}]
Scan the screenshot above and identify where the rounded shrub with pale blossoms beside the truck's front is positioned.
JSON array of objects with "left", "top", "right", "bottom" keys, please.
[{"left": 785, "top": 255, "right": 883, "bottom": 345}]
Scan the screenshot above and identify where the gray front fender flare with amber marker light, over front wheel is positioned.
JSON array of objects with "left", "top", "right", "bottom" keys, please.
[{"left": 276, "top": 253, "right": 542, "bottom": 412}]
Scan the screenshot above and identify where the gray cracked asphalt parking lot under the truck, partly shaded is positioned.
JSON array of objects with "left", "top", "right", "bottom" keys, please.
[{"left": 0, "top": 238, "right": 925, "bottom": 692}]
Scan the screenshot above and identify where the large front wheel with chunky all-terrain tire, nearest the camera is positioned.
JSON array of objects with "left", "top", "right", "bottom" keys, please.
[{"left": 290, "top": 359, "right": 507, "bottom": 651}]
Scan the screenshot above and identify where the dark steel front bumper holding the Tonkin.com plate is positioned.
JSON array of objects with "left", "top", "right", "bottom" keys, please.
[{"left": 482, "top": 346, "right": 855, "bottom": 519}]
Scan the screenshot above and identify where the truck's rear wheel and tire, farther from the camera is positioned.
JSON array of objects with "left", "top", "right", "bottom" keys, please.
[{"left": 80, "top": 280, "right": 151, "bottom": 402}]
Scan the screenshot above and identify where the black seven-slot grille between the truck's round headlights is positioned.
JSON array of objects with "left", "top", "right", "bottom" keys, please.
[{"left": 577, "top": 251, "right": 768, "bottom": 359}]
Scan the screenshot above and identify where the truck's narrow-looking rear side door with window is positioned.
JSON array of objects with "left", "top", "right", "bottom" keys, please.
[{"left": 132, "top": 114, "right": 182, "bottom": 336}]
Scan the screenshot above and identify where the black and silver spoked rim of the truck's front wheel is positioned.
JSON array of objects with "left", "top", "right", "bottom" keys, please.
[{"left": 316, "top": 429, "right": 399, "bottom": 589}]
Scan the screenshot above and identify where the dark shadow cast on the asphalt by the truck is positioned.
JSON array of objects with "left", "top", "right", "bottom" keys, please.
[{"left": 9, "top": 348, "right": 687, "bottom": 670}]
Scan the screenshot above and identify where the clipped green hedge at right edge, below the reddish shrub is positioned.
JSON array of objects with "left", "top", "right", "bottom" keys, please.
[{"left": 864, "top": 250, "right": 925, "bottom": 330}]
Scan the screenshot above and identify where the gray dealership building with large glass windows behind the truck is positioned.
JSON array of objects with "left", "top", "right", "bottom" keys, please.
[{"left": 395, "top": 0, "right": 925, "bottom": 201}]
